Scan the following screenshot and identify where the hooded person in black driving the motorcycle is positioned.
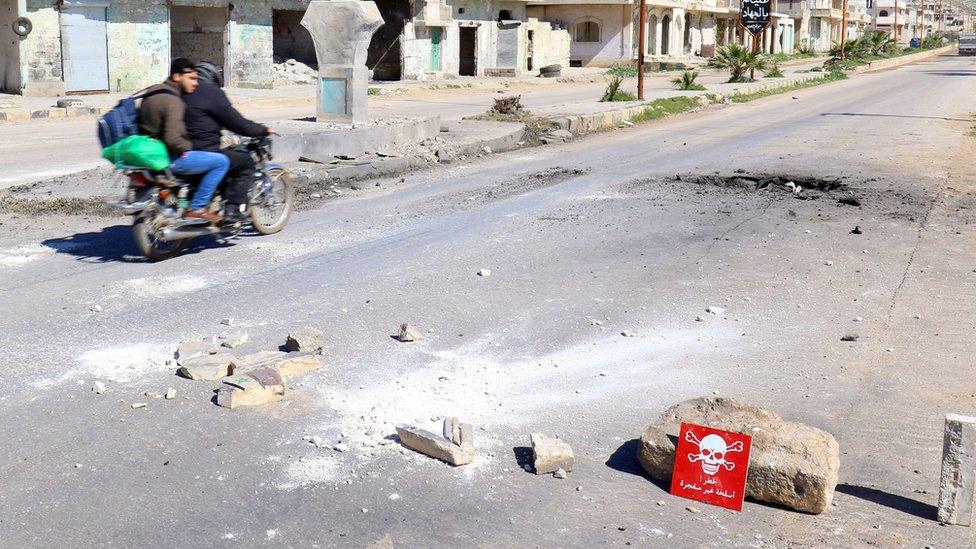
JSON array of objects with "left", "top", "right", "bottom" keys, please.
[{"left": 183, "top": 61, "right": 274, "bottom": 220}]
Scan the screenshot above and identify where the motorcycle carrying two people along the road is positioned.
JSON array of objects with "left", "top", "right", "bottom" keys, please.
[{"left": 112, "top": 137, "right": 295, "bottom": 261}]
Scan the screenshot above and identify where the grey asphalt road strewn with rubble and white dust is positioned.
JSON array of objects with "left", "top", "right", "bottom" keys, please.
[{"left": 0, "top": 53, "right": 976, "bottom": 547}]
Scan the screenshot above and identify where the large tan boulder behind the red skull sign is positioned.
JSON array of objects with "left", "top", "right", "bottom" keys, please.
[{"left": 637, "top": 398, "right": 840, "bottom": 514}]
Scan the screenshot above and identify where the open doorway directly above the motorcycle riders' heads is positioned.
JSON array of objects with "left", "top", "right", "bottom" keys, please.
[{"left": 169, "top": 6, "right": 230, "bottom": 74}]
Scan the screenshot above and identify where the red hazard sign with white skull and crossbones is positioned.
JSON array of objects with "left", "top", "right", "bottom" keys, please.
[{"left": 671, "top": 423, "right": 752, "bottom": 511}]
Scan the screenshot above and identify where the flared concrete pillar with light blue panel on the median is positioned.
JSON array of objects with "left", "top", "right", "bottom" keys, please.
[{"left": 302, "top": 0, "right": 383, "bottom": 122}]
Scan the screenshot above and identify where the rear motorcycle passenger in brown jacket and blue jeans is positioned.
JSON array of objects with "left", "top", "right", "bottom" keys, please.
[{"left": 139, "top": 57, "right": 230, "bottom": 223}]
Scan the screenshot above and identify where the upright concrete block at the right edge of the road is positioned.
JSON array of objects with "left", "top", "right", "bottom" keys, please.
[{"left": 939, "top": 414, "right": 976, "bottom": 526}]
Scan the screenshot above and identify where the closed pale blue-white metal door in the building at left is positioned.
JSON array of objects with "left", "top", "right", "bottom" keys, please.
[{"left": 60, "top": 0, "right": 108, "bottom": 93}]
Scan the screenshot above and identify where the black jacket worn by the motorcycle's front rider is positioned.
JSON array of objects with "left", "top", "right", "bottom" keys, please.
[{"left": 183, "top": 79, "right": 268, "bottom": 152}]
